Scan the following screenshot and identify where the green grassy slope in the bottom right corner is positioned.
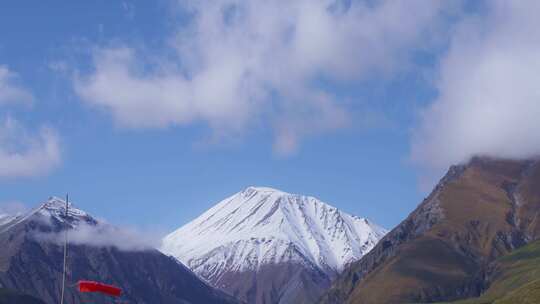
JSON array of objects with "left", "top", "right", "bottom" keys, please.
[{"left": 436, "top": 241, "right": 540, "bottom": 304}]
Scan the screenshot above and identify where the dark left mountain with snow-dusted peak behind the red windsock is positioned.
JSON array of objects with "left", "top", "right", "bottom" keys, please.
[{"left": 0, "top": 198, "right": 240, "bottom": 304}]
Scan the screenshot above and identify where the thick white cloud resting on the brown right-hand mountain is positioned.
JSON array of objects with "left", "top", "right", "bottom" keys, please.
[{"left": 412, "top": 0, "right": 540, "bottom": 168}]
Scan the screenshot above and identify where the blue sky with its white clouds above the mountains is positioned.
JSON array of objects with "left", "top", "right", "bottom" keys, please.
[{"left": 0, "top": 0, "right": 540, "bottom": 231}]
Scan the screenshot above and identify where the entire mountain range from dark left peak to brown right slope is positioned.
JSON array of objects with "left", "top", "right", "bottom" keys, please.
[{"left": 0, "top": 157, "right": 540, "bottom": 304}]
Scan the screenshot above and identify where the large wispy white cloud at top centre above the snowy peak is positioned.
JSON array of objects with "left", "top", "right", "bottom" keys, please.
[{"left": 75, "top": 0, "right": 446, "bottom": 153}]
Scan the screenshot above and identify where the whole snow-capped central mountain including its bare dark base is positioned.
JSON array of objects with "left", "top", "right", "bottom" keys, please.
[{"left": 162, "top": 187, "right": 386, "bottom": 303}]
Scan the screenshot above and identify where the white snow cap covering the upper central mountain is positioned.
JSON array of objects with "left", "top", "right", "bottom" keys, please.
[{"left": 161, "top": 187, "right": 386, "bottom": 281}]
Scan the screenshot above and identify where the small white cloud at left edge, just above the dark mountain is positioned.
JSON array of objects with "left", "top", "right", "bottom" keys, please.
[{"left": 0, "top": 117, "right": 61, "bottom": 178}]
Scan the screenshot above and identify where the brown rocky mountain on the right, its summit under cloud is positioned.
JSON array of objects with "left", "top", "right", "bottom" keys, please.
[{"left": 320, "top": 158, "right": 540, "bottom": 304}]
